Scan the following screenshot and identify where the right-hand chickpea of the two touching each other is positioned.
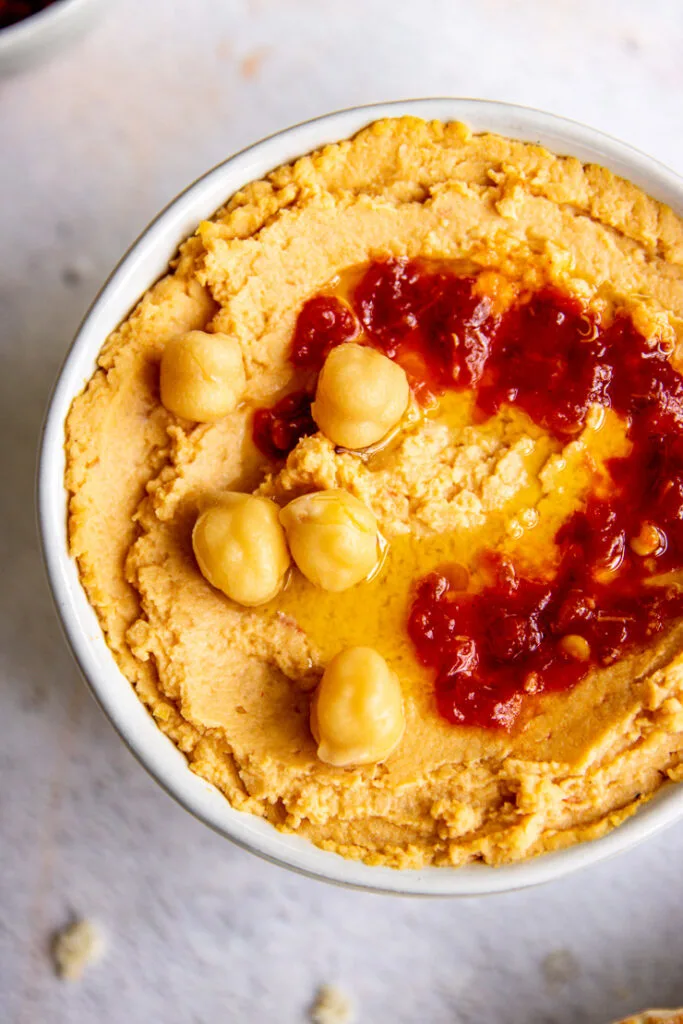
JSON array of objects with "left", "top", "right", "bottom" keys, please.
[{"left": 280, "top": 488, "right": 380, "bottom": 591}]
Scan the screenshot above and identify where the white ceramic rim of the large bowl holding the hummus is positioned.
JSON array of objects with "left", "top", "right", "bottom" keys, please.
[{"left": 38, "top": 99, "right": 683, "bottom": 896}]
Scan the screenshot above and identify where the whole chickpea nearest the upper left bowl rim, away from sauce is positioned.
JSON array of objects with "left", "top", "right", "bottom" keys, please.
[{"left": 160, "top": 331, "right": 246, "bottom": 423}]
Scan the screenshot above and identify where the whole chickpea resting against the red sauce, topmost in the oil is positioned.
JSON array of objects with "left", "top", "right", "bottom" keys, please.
[{"left": 311, "top": 343, "right": 410, "bottom": 449}]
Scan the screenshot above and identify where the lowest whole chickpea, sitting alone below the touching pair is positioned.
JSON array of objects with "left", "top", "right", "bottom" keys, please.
[{"left": 310, "top": 647, "right": 405, "bottom": 768}]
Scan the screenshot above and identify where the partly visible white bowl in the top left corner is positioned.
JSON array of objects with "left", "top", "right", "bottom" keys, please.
[{"left": 0, "top": 0, "right": 102, "bottom": 76}]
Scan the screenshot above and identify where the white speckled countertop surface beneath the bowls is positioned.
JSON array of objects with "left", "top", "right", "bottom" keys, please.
[{"left": 0, "top": 0, "right": 683, "bottom": 1024}]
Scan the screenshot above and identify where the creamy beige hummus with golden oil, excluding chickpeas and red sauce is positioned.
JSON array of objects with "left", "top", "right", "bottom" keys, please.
[{"left": 67, "top": 118, "right": 683, "bottom": 867}]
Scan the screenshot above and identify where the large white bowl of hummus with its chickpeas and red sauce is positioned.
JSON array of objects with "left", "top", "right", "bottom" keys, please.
[{"left": 38, "top": 99, "right": 683, "bottom": 895}]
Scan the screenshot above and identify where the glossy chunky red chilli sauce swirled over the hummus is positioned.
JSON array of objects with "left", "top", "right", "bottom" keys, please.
[{"left": 255, "top": 260, "right": 683, "bottom": 729}]
